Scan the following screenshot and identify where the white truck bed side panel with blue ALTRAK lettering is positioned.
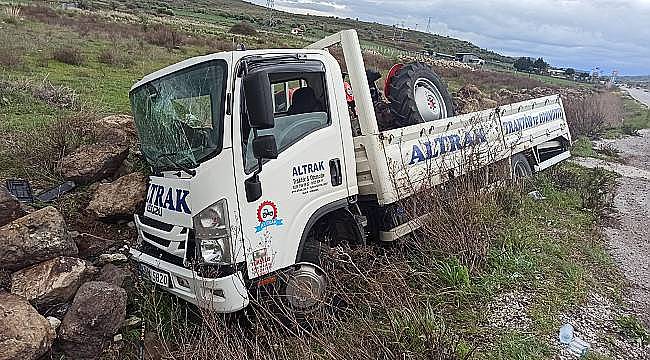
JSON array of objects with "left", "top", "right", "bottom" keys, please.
[{"left": 354, "top": 95, "right": 571, "bottom": 205}]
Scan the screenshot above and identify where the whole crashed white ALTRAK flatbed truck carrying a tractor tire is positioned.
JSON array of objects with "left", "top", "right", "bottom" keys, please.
[{"left": 130, "top": 30, "right": 571, "bottom": 313}]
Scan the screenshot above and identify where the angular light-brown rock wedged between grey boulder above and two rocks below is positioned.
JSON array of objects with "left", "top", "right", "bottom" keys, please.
[{"left": 11, "top": 256, "right": 93, "bottom": 309}]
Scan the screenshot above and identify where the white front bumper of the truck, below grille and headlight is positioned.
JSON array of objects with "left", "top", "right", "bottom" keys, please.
[{"left": 129, "top": 248, "right": 249, "bottom": 313}]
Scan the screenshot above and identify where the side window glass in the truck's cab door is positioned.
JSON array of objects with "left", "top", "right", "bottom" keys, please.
[{"left": 242, "top": 72, "right": 331, "bottom": 173}]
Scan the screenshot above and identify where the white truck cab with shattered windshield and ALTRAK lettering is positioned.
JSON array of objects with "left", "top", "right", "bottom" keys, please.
[{"left": 130, "top": 49, "right": 358, "bottom": 312}]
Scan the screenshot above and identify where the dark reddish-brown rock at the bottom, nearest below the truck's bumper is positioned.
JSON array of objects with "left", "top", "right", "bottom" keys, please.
[{"left": 59, "top": 281, "right": 126, "bottom": 359}]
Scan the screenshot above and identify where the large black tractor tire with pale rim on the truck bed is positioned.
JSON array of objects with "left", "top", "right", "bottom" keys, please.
[{"left": 388, "top": 62, "right": 454, "bottom": 127}]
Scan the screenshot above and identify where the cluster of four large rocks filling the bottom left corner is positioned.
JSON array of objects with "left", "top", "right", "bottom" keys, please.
[{"left": 0, "top": 201, "right": 128, "bottom": 359}]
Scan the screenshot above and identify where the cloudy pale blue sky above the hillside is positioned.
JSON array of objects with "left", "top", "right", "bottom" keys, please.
[{"left": 244, "top": 0, "right": 650, "bottom": 75}]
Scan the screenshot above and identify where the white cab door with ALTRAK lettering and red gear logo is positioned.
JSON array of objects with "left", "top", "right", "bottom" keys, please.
[{"left": 233, "top": 55, "right": 356, "bottom": 278}]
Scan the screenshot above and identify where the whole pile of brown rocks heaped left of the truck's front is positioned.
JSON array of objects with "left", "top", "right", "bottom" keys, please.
[{"left": 0, "top": 116, "right": 146, "bottom": 360}]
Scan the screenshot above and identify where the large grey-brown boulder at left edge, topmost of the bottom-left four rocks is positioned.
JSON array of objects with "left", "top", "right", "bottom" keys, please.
[{"left": 0, "top": 206, "right": 77, "bottom": 270}]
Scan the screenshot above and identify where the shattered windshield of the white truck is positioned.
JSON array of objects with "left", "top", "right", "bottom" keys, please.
[{"left": 131, "top": 60, "right": 227, "bottom": 171}]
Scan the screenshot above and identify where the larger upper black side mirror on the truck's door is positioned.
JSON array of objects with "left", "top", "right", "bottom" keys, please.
[{"left": 244, "top": 71, "right": 275, "bottom": 130}]
